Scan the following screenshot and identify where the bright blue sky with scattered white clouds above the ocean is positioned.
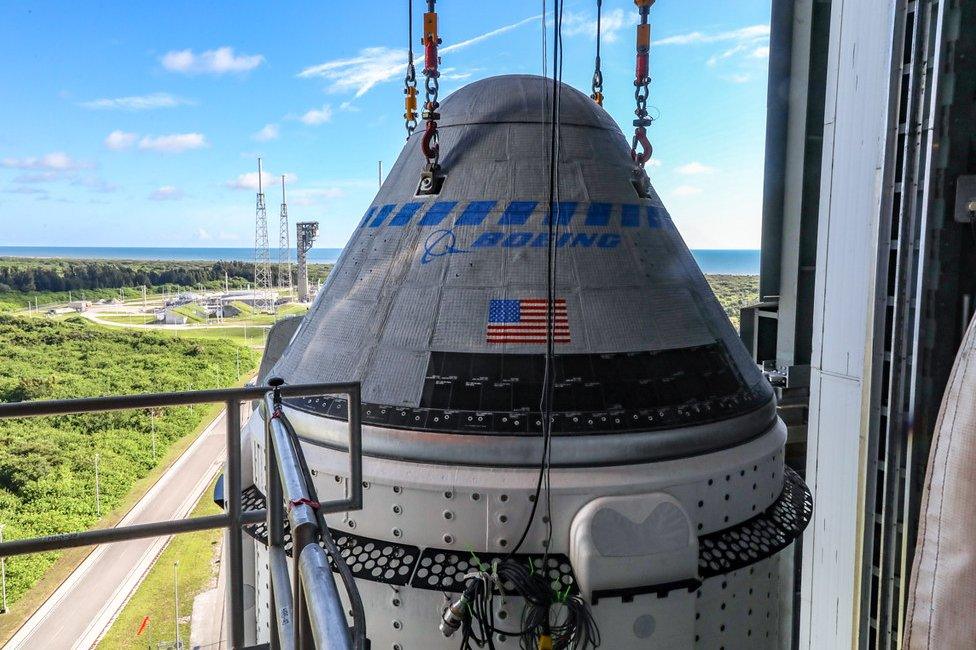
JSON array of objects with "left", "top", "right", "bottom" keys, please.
[{"left": 0, "top": 0, "right": 769, "bottom": 248}]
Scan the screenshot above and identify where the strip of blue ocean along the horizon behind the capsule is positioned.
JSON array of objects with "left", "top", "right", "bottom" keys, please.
[{"left": 0, "top": 246, "right": 759, "bottom": 275}]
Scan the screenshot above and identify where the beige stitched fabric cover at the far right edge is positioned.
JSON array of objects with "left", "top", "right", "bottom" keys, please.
[{"left": 905, "top": 312, "right": 976, "bottom": 648}]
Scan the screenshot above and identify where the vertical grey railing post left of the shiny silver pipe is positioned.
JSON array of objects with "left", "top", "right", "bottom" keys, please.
[{"left": 224, "top": 399, "right": 244, "bottom": 650}]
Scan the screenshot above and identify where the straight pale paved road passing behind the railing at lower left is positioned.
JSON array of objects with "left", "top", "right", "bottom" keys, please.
[{"left": 4, "top": 412, "right": 233, "bottom": 650}]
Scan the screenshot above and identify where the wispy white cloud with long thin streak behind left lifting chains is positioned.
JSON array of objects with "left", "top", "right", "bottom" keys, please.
[{"left": 298, "top": 15, "right": 542, "bottom": 97}]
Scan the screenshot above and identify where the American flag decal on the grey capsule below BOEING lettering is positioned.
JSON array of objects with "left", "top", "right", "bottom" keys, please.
[{"left": 487, "top": 298, "right": 570, "bottom": 343}]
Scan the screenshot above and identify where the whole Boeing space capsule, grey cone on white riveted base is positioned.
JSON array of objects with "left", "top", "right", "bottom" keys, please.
[{"left": 245, "top": 75, "right": 811, "bottom": 650}]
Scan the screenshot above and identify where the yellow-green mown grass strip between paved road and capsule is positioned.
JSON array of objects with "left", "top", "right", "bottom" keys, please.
[{"left": 97, "top": 476, "right": 223, "bottom": 650}]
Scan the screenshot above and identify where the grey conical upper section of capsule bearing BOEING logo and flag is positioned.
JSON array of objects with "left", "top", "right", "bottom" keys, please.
[{"left": 274, "top": 75, "right": 773, "bottom": 449}]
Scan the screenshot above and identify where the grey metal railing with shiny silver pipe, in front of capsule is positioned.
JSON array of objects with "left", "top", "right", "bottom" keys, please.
[{"left": 0, "top": 383, "right": 362, "bottom": 649}]
